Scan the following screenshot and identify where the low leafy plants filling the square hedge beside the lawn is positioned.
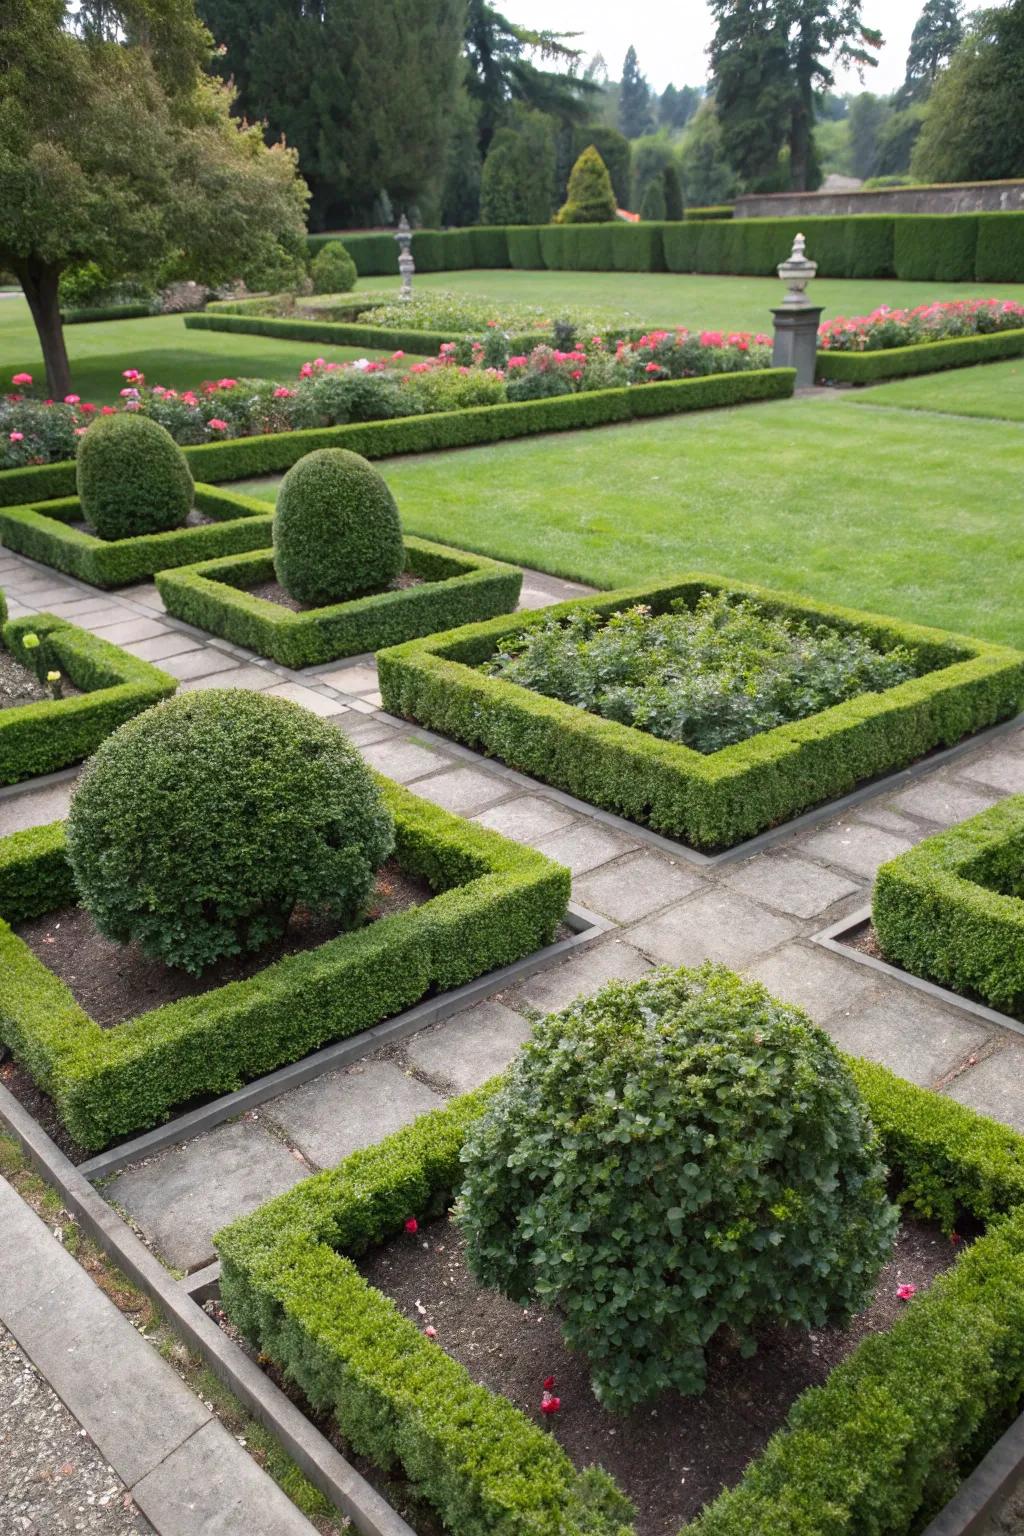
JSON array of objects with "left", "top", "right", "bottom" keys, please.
[{"left": 484, "top": 593, "right": 913, "bottom": 753}]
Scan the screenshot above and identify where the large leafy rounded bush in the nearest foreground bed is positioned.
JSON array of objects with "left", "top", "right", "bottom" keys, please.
[{"left": 459, "top": 966, "right": 897, "bottom": 1409}]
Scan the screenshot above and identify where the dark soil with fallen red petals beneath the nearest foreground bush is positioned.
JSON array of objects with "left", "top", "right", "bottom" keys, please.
[{"left": 359, "top": 1220, "right": 958, "bottom": 1536}]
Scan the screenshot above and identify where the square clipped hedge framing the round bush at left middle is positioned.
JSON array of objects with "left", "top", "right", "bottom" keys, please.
[{"left": 0, "top": 776, "right": 571, "bottom": 1150}]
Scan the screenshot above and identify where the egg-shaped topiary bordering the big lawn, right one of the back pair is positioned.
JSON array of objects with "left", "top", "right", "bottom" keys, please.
[{"left": 273, "top": 449, "right": 405, "bottom": 607}]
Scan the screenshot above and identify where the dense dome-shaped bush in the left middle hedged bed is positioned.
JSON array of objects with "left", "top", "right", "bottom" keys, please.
[{"left": 68, "top": 688, "right": 395, "bottom": 972}]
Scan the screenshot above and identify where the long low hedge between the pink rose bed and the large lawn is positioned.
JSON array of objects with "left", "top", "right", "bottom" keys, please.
[{"left": 0, "top": 369, "right": 797, "bottom": 506}]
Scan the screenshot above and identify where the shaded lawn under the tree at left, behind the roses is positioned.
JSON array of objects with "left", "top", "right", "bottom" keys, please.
[{"left": 0, "top": 298, "right": 396, "bottom": 404}]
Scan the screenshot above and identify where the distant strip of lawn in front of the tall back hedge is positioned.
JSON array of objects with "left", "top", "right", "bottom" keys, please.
[{"left": 356, "top": 273, "right": 1024, "bottom": 339}]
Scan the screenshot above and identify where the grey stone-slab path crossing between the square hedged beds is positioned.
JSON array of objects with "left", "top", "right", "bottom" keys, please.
[{"left": 0, "top": 550, "right": 1024, "bottom": 1270}]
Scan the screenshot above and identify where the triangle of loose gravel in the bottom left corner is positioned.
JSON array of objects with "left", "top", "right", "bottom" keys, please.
[{"left": 0, "top": 1324, "right": 152, "bottom": 1536}]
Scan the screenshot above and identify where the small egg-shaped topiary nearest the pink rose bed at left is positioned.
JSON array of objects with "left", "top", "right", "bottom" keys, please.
[{"left": 75, "top": 413, "right": 193, "bottom": 539}]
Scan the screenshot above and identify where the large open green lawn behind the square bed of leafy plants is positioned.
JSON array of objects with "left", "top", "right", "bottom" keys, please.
[{"left": 230, "top": 396, "right": 1024, "bottom": 647}]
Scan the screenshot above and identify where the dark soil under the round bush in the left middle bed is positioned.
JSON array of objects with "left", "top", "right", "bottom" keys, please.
[{"left": 15, "top": 859, "right": 433, "bottom": 1029}]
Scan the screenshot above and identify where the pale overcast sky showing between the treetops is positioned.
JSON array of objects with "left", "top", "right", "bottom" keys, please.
[{"left": 512, "top": 0, "right": 924, "bottom": 95}]
